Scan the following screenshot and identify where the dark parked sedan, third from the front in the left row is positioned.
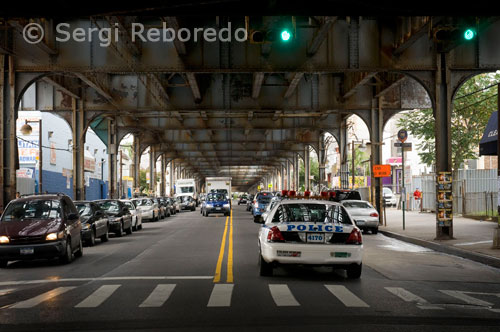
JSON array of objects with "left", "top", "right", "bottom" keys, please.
[{"left": 95, "top": 199, "right": 132, "bottom": 237}]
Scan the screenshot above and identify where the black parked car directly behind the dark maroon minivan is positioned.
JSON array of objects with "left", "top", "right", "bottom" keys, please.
[{"left": 74, "top": 201, "right": 109, "bottom": 246}]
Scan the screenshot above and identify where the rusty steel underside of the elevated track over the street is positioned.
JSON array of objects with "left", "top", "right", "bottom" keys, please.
[{"left": 10, "top": 13, "right": 496, "bottom": 186}]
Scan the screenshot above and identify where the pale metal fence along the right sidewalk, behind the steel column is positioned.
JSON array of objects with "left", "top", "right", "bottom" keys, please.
[{"left": 407, "top": 169, "right": 498, "bottom": 216}]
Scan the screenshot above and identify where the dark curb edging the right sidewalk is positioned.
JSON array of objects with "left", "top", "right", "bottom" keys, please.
[{"left": 379, "top": 228, "right": 500, "bottom": 269}]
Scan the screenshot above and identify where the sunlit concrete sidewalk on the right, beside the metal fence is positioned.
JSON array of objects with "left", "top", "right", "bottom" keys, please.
[{"left": 379, "top": 208, "right": 500, "bottom": 268}]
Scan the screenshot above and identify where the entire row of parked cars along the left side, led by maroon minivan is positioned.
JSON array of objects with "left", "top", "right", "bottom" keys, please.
[{"left": 0, "top": 193, "right": 189, "bottom": 267}]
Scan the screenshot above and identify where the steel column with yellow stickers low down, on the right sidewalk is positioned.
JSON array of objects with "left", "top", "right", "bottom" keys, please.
[{"left": 435, "top": 53, "right": 453, "bottom": 240}]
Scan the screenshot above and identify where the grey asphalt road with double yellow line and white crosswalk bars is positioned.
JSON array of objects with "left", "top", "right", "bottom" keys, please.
[{"left": 0, "top": 204, "right": 500, "bottom": 332}]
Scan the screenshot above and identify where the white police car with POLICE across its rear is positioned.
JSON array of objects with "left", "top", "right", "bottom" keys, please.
[{"left": 259, "top": 199, "right": 363, "bottom": 279}]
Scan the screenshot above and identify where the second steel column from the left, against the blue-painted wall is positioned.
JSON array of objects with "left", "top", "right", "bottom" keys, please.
[{"left": 71, "top": 98, "right": 85, "bottom": 200}]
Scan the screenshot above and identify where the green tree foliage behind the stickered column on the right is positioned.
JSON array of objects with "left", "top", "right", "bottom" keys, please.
[{"left": 398, "top": 71, "right": 500, "bottom": 170}]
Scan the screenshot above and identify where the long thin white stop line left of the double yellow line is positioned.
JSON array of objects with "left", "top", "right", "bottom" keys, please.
[{"left": 0, "top": 276, "right": 214, "bottom": 287}]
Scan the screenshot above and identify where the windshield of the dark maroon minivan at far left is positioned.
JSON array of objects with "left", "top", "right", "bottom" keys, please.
[{"left": 2, "top": 199, "right": 61, "bottom": 221}]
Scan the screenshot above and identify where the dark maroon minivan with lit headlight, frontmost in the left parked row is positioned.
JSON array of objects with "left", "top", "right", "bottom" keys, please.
[{"left": 0, "top": 194, "right": 83, "bottom": 267}]
